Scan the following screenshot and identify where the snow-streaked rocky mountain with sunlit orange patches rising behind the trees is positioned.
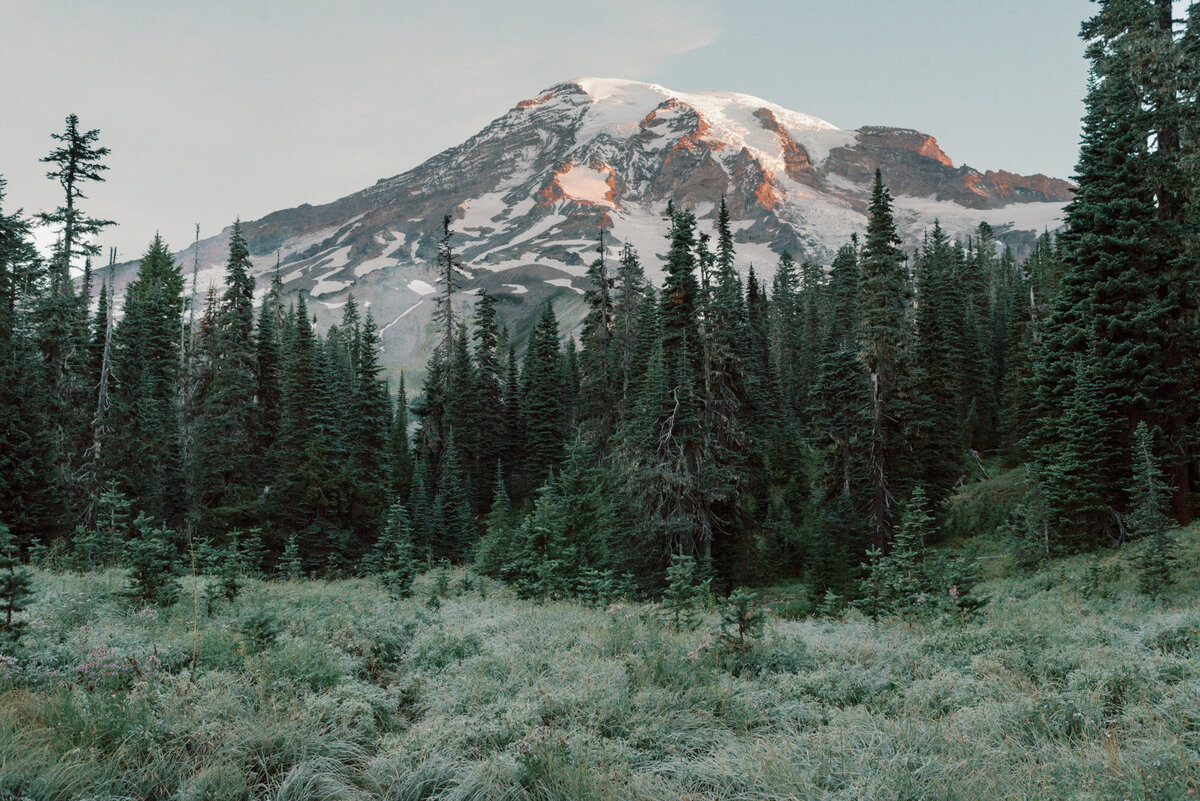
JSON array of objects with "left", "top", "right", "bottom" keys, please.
[{"left": 127, "top": 78, "right": 1072, "bottom": 367}]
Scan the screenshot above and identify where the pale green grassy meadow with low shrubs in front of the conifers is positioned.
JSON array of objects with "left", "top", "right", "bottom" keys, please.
[{"left": 0, "top": 526, "right": 1200, "bottom": 801}]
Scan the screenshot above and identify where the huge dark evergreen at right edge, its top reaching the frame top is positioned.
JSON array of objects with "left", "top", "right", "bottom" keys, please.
[{"left": 1031, "top": 0, "right": 1200, "bottom": 546}]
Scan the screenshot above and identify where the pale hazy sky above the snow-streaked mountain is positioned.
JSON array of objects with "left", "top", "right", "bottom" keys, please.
[{"left": 0, "top": 0, "right": 1094, "bottom": 259}]
